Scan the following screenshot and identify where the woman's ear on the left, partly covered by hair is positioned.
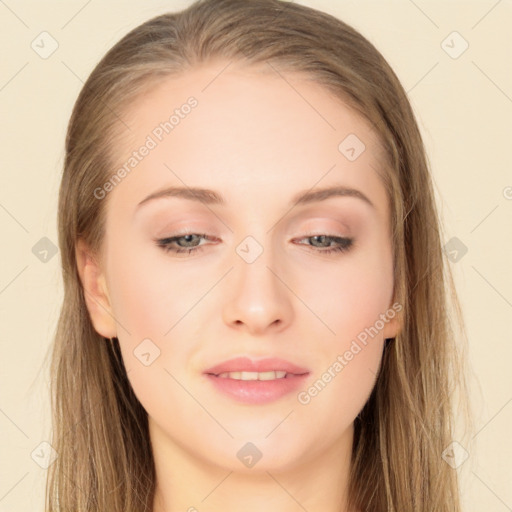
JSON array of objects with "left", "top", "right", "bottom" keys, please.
[{"left": 75, "top": 239, "right": 117, "bottom": 338}]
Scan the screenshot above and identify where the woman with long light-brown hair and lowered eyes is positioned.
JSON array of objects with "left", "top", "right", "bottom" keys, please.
[{"left": 47, "top": 0, "right": 472, "bottom": 512}]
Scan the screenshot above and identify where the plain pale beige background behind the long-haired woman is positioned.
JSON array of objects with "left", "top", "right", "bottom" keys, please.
[{"left": 0, "top": 0, "right": 512, "bottom": 512}]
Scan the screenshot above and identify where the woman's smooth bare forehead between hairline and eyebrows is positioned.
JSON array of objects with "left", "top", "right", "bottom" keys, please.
[{"left": 107, "top": 61, "right": 385, "bottom": 218}]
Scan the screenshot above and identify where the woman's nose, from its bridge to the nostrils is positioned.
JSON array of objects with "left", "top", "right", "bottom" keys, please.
[{"left": 222, "top": 244, "right": 294, "bottom": 335}]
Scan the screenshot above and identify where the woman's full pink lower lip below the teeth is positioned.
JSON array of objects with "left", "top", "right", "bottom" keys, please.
[{"left": 206, "top": 373, "right": 308, "bottom": 404}]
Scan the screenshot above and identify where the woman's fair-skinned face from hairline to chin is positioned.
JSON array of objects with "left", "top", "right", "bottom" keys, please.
[{"left": 81, "top": 62, "right": 397, "bottom": 471}]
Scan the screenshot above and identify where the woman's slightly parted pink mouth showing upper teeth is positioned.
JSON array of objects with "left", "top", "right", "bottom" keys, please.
[{"left": 204, "top": 357, "right": 310, "bottom": 404}]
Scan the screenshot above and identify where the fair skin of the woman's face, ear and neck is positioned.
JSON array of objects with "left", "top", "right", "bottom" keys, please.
[{"left": 77, "top": 62, "right": 399, "bottom": 512}]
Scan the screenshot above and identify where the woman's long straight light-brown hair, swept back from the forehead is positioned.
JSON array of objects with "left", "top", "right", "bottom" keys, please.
[{"left": 46, "top": 0, "right": 471, "bottom": 512}]
